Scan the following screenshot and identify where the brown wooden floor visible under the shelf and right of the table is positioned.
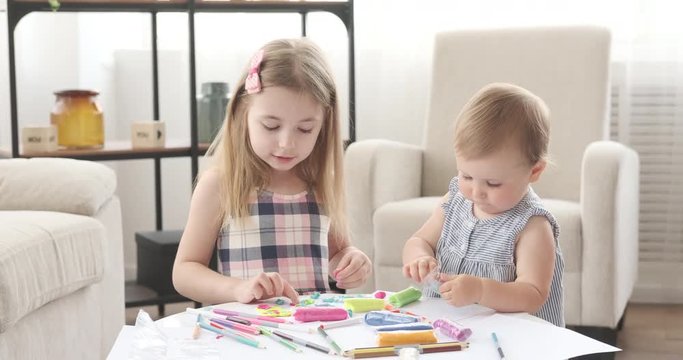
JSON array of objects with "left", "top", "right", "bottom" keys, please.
[{"left": 126, "top": 302, "right": 683, "bottom": 360}]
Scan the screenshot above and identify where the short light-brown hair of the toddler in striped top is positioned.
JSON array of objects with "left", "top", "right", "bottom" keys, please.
[{"left": 455, "top": 83, "right": 550, "bottom": 165}]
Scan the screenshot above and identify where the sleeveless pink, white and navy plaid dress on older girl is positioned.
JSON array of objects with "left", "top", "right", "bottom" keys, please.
[{"left": 216, "top": 190, "right": 330, "bottom": 293}]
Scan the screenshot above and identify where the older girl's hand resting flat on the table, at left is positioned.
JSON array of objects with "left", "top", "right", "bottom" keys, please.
[{"left": 235, "top": 273, "right": 299, "bottom": 304}]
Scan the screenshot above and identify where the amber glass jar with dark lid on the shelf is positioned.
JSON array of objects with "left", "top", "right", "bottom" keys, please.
[{"left": 50, "top": 90, "right": 104, "bottom": 149}]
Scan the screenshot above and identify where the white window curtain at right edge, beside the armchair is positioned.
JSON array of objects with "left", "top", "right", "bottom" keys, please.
[{"left": 610, "top": 1, "right": 683, "bottom": 303}]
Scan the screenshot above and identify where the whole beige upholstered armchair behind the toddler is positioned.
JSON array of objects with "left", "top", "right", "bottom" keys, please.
[{"left": 345, "top": 27, "right": 639, "bottom": 346}]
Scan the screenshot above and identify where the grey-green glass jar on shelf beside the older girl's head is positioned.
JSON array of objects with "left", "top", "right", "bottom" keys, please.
[{"left": 197, "top": 82, "right": 230, "bottom": 143}]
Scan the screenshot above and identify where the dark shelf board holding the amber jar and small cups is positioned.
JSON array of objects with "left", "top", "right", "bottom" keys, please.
[{"left": 2, "top": 140, "right": 209, "bottom": 160}]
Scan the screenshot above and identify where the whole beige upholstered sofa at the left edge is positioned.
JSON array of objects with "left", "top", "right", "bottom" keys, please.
[{"left": 0, "top": 158, "right": 125, "bottom": 360}]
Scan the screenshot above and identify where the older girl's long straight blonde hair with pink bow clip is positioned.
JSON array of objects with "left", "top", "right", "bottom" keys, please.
[{"left": 207, "top": 39, "right": 348, "bottom": 241}]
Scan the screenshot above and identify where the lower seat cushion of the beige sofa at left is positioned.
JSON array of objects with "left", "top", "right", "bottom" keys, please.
[{"left": 0, "top": 211, "right": 105, "bottom": 333}]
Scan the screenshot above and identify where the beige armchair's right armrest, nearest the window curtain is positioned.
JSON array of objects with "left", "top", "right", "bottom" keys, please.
[{"left": 580, "top": 141, "right": 639, "bottom": 328}]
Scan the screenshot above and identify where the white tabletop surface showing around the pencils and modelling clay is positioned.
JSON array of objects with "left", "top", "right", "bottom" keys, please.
[{"left": 108, "top": 299, "right": 619, "bottom": 360}]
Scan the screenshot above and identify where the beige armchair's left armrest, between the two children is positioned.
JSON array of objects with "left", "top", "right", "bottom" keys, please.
[{"left": 344, "top": 140, "right": 422, "bottom": 270}]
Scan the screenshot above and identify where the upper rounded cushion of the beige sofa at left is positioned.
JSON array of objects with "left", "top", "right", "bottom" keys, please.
[{"left": 0, "top": 158, "right": 116, "bottom": 215}]
